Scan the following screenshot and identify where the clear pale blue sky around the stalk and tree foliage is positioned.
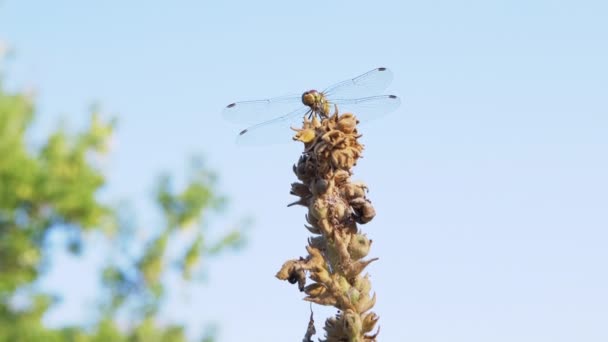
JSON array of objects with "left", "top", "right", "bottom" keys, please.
[{"left": 0, "top": 0, "right": 608, "bottom": 342}]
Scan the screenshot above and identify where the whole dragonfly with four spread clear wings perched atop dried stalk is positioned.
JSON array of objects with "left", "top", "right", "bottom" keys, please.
[{"left": 222, "top": 68, "right": 401, "bottom": 145}]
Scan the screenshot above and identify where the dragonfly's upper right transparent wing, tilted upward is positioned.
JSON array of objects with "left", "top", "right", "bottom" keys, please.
[{"left": 323, "top": 68, "right": 393, "bottom": 100}]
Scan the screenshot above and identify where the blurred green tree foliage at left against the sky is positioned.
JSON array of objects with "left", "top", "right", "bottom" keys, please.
[{"left": 0, "top": 69, "right": 243, "bottom": 342}]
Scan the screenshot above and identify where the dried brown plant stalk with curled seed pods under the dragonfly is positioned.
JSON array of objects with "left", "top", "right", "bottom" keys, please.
[{"left": 276, "top": 108, "right": 378, "bottom": 342}]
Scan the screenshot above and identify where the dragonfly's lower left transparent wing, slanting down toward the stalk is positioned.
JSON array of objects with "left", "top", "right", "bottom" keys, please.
[{"left": 236, "top": 107, "right": 310, "bottom": 145}]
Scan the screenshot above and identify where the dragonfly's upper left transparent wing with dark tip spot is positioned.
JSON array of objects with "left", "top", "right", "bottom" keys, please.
[{"left": 222, "top": 95, "right": 304, "bottom": 125}]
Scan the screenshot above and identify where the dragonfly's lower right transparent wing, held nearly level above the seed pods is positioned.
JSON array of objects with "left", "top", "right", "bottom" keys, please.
[{"left": 331, "top": 95, "right": 401, "bottom": 123}]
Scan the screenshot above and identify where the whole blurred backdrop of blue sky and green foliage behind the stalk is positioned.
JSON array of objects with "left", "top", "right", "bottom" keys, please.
[{"left": 0, "top": 0, "right": 608, "bottom": 342}]
